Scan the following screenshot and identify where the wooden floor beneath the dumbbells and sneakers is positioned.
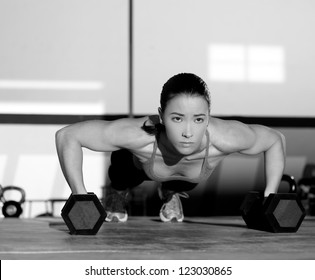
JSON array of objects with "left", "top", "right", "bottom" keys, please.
[{"left": 0, "top": 217, "right": 315, "bottom": 260}]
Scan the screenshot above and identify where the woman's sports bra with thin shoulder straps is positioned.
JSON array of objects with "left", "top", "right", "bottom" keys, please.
[{"left": 142, "top": 130, "right": 211, "bottom": 184}]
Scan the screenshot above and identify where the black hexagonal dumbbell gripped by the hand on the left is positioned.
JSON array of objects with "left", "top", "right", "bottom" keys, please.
[{"left": 61, "top": 193, "right": 106, "bottom": 235}]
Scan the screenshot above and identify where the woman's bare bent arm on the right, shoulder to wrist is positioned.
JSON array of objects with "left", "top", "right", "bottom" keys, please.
[{"left": 211, "top": 118, "right": 286, "bottom": 196}]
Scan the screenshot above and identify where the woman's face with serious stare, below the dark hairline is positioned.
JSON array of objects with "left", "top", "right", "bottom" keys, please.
[{"left": 160, "top": 94, "right": 209, "bottom": 155}]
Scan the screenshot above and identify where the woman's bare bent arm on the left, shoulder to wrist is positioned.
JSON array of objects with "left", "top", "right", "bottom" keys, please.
[{"left": 56, "top": 119, "right": 149, "bottom": 194}]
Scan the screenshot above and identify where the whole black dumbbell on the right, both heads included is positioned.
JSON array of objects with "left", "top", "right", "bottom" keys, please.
[{"left": 240, "top": 174, "right": 306, "bottom": 233}]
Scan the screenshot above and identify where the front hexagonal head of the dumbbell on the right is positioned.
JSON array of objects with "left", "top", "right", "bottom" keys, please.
[{"left": 264, "top": 194, "right": 306, "bottom": 232}]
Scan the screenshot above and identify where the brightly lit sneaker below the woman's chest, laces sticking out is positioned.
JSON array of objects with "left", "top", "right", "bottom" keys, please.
[{"left": 159, "top": 188, "right": 188, "bottom": 223}]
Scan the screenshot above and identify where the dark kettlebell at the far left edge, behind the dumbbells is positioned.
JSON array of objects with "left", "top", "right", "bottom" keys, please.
[{"left": 0, "top": 186, "right": 25, "bottom": 218}]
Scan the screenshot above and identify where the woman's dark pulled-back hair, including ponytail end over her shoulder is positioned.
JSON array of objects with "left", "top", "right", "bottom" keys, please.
[{"left": 142, "top": 73, "right": 211, "bottom": 135}]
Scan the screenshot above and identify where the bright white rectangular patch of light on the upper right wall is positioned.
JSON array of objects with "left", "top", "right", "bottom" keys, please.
[{"left": 208, "top": 44, "right": 285, "bottom": 83}]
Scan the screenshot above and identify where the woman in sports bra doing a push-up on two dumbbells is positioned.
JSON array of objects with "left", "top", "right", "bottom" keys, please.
[{"left": 56, "top": 73, "right": 285, "bottom": 222}]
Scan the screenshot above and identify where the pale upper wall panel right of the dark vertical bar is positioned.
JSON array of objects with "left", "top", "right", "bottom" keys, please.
[{"left": 134, "top": 0, "right": 315, "bottom": 117}]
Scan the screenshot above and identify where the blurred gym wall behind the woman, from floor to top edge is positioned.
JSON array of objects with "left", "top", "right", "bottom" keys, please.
[{"left": 0, "top": 0, "right": 315, "bottom": 218}]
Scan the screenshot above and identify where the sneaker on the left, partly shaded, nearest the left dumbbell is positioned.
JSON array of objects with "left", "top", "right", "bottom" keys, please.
[{"left": 105, "top": 187, "right": 128, "bottom": 223}]
